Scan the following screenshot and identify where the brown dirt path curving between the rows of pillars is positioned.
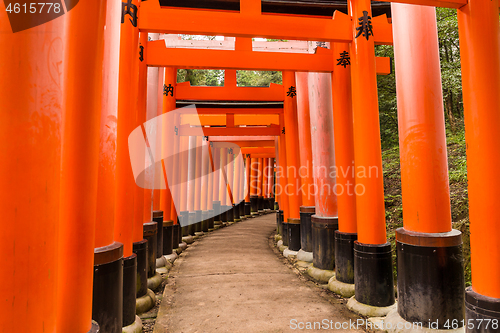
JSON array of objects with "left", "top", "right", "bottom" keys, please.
[{"left": 154, "top": 214, "right": 363, "bottom": 333}]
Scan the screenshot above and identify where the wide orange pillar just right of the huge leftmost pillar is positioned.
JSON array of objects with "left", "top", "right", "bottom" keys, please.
[{"left": 57, "top": 1, "right": 109, "bottom": 333}]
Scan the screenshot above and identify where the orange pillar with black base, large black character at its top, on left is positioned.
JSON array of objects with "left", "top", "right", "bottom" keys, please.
[{"left": 115, "top": 0, "right": 139, "bottom": 327}]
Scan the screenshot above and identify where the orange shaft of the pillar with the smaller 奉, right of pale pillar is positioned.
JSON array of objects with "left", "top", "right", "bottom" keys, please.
[{"left": 332, "top": 43, "right": 357, "bottom": 233}]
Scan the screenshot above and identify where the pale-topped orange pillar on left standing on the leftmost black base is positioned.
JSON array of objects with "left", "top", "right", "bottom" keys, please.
[{"left": 92, "top": 1, "right": 123, "bottom": 333}]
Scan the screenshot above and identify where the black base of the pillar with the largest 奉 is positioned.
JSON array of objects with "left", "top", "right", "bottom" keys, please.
[{"left": 354, "top": 241, "right": 394, "bottom": 307}]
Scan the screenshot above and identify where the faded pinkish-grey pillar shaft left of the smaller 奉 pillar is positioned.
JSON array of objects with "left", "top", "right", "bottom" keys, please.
[{"left": 308, "top": 73, "right": 338, "bottom": 217}]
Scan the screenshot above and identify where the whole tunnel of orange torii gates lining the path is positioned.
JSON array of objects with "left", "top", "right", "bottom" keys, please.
[{"left": 0, "top": 0, "right": 500, "bottom": 333}]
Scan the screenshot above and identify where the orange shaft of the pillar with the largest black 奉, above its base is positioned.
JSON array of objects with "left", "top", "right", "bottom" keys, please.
[{"left": 349, "top": 0, "right": 387, "bottom": 244}]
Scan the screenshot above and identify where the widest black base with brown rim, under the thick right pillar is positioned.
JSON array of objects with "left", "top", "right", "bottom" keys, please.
[{"left": 396, "top": 228, "right": 465, "bottom": 329}]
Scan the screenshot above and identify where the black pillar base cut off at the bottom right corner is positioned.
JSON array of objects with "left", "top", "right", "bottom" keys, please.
[{"left": 465, "top": 287, "right": 500, "bottom": 333}]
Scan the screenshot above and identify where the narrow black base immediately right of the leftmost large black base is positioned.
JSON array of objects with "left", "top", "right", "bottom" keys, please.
[{"left": 122, "top": 253, "right": 137, "bottom": 327}]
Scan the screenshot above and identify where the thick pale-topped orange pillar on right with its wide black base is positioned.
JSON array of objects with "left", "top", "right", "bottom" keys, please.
[{"left": 391, "top": 4, "right": 464, "bottom": 329}]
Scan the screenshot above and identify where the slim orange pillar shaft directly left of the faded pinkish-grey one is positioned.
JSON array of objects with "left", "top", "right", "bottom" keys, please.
[{"left": 295, "top": 72, "right": 314, "bottom": 207}]
